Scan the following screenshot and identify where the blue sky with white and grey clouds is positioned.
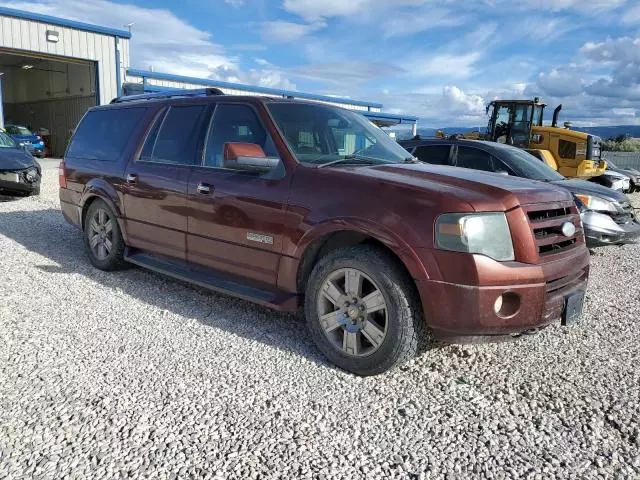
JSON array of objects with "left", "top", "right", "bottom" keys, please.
[{"left": 5, "top": 0, "right": 640, "bottom": 127}]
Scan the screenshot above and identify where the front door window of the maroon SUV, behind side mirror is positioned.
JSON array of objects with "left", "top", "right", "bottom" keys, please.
[{"left": 204, "top": 104, "right": 278, "bottom": 167}]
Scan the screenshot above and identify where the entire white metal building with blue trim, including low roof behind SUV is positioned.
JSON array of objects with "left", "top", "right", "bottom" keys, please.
[{"left": 0, "top": 7, "right": 417, "bottom": 156}]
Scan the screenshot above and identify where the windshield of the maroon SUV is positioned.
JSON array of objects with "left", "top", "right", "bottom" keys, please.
[{"left": 268, "top": 102, "right": 411, "bottom": 165}]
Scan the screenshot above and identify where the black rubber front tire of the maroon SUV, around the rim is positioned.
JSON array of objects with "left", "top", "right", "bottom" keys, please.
[{"left": 305, "top": 246, "right": 425, "bottom": 376}]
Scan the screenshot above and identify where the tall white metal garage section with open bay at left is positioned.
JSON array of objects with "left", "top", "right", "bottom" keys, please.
[{"left": 0, "top": 7, "right": 131, "bottom": 156}]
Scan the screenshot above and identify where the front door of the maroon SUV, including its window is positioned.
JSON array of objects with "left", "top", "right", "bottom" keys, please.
[{"left": 187, "top": 103, "right": 291, "bottom": 285}]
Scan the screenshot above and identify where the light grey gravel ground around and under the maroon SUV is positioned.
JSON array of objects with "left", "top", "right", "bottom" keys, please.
[{"left": 0, "top": 170, "right": 640, "bottom": 479}]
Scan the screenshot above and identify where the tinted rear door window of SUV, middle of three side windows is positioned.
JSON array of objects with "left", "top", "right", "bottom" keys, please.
[{"left": 140, "top": 105, "right": 206, "bottom": 165}]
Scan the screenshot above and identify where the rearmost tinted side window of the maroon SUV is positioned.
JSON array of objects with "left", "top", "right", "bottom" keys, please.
[{"left": 67, "top": 107, "right": 146, "bottom": 162}]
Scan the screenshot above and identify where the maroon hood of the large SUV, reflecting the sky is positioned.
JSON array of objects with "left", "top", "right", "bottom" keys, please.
[{"left": 342, "top": 163, "right": 573, "bottom": 211}]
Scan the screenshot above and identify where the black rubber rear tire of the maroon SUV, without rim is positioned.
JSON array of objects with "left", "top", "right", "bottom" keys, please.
[{"left": 83, "top": 199, "right": 128, "bottom": 271}]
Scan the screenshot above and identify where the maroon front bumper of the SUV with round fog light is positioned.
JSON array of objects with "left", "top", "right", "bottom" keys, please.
[{"left": 417, "top": 246, "right": 589, "bottom": 343}]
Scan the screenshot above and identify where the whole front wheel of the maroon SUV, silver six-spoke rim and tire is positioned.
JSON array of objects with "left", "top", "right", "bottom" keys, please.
[{"left": 305, "top": 246, "right": 423, "bottom": 375}]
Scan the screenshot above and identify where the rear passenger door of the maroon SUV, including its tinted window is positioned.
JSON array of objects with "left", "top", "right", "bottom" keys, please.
[{"left": 124, "top": 103, "right": 209, "bottom": 260}]
